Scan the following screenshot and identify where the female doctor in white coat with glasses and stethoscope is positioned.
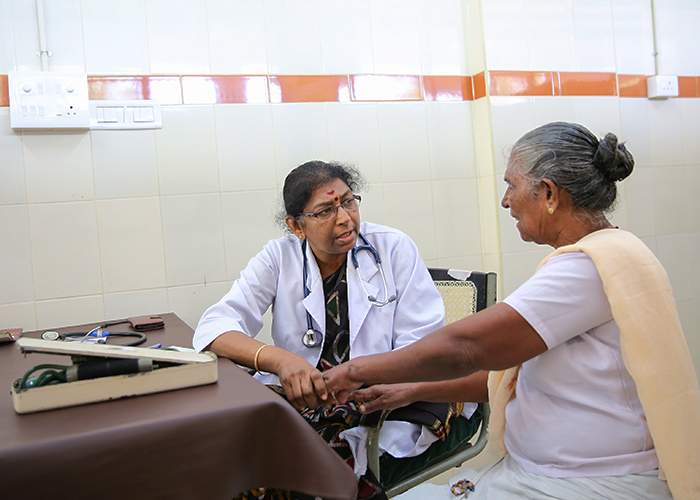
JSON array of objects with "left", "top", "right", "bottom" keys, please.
[{"left": 193, "top": 161, "right": 470, "bottom": 498}]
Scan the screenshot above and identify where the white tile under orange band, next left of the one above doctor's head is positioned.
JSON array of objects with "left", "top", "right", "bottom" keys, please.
[{"left": 214, "top": 104, "right": 277, "bottom": 191}]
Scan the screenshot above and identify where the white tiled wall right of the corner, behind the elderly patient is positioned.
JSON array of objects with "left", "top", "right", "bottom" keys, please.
[{"left": 482, "top": 0, "right": 700, "bottom": 367}]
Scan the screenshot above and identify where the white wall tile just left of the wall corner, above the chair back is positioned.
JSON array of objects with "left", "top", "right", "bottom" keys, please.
[{"left": 433, "top": 179, "right": 481, "bottom": 257}]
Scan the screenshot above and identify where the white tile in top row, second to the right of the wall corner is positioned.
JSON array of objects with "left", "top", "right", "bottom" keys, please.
[{"left": 523, "top": 0, "right": 574, "bottom": 71}]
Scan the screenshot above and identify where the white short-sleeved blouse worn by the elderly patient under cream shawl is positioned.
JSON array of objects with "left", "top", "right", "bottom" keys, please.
[{"left": 504, "top": 253, "right": 658, "bottom": 477}]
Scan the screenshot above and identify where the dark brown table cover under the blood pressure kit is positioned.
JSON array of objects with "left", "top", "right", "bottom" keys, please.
[{"left": 0, "top": 313, "right": 357, "bottom": 500}]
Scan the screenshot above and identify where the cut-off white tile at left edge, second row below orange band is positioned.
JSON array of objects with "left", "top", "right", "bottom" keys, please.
[{"left": 0, "top": 205, "right": 34, "bottom": 304}]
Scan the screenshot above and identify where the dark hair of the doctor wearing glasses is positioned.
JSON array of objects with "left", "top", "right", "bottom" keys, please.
[{"left": 282, "top": 160, "right": 365, "bottom": 217}]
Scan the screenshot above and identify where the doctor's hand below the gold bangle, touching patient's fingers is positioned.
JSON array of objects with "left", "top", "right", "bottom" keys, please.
[{"left": 275, "top": 351, "right": 328, "bottom": 410}]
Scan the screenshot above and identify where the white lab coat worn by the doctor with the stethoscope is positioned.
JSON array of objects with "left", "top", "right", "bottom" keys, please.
[{"left": 193, "top": 222, "right": 445, "bottom": 475}]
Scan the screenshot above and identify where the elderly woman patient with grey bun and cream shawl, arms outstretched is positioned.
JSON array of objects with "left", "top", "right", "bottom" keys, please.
[{"left": 324, "top": 122, "right": 700, "bottom": 500}]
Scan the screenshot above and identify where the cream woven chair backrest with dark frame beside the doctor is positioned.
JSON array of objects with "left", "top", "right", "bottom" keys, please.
[{"left": 428, "top": 268, "right": 496, "bottom": 324}]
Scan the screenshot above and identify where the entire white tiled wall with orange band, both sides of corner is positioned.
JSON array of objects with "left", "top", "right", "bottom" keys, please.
[{"left": 0, "top": 0, "right": 700, "bottom": 376}]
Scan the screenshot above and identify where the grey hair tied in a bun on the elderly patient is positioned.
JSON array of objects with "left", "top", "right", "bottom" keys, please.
[{"left": 510, "top": 122, "right": 634, "bottom": 214}]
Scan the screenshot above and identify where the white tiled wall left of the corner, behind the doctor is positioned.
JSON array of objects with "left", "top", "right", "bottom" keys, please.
[{"left": 0, "top": 0, "right": 482, "bottom": 336}]
